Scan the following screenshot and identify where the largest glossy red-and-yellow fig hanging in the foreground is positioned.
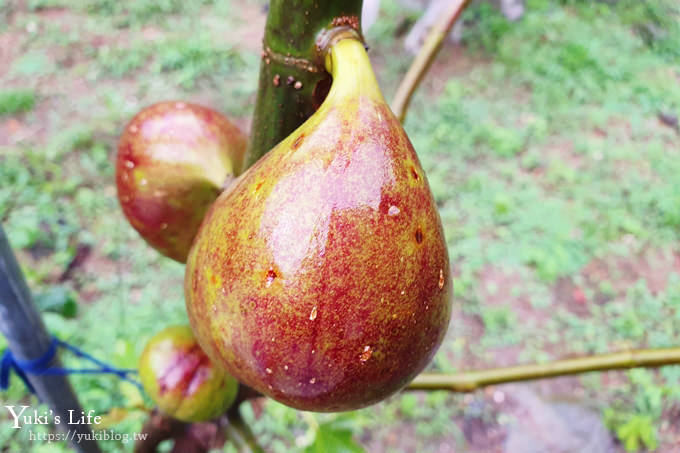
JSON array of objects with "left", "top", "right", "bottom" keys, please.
[{"left": 185, "top": 39, "right": 452, "bottom": 411}]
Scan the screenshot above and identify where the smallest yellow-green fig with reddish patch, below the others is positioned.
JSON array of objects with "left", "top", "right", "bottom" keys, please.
[{"left": 139, "top": 326, "right": 238, "bottom": 422}]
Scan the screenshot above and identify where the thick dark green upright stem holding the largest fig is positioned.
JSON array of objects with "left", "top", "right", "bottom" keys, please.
[{"left": 245, "top": 0, "right": 363, "bottom": 168}]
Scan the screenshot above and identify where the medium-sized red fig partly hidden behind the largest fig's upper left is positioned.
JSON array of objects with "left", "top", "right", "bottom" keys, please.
[{"left": 116, "top": 102, "right": 246, "bottom": 262}]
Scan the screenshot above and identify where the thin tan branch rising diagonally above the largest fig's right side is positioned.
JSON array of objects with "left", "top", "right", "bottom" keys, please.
[{"left": 392, "top": 0, "right": 470, "bottom": 124}]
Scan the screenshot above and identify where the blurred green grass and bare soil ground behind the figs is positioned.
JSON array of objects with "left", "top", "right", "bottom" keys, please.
[{"left": 0, "top": 0, "right": 680, "bottom": 452}]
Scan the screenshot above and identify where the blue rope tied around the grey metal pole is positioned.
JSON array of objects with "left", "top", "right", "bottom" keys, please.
[{"left": 0, "top": 337, "right": 142, "bottom": 393}]
